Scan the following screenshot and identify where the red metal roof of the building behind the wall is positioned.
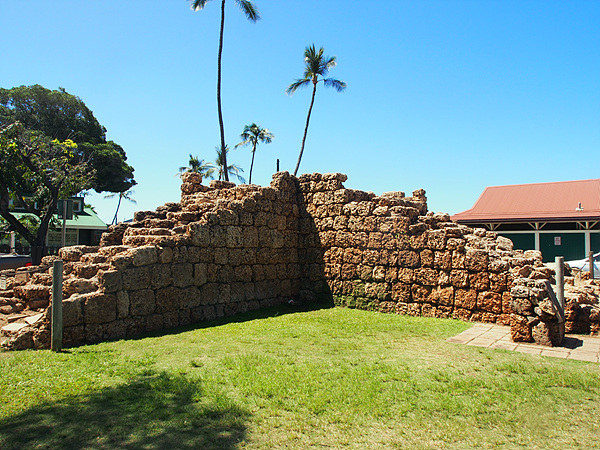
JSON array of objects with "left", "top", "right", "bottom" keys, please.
[{"left": 452, "top": 178, "right": 600, "bottom": 223}]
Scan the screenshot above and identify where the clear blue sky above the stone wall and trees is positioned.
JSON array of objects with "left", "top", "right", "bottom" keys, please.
[{"left": 0, "top": 0, "right": 600, "bottom": 222}]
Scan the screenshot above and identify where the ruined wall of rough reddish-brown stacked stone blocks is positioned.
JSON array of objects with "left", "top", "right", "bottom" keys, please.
[{"left": 0, "top": 172, "right": 600, "bottom": 349}]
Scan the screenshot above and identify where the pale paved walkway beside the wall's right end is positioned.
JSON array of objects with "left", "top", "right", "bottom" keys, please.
[{"left": 447, "top": 323, "right": 600, "bottom": 363}]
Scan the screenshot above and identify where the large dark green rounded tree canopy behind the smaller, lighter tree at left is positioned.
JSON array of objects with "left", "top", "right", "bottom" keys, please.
[{"left": 0, "top": 85, "right": 136, "bottom": 192}]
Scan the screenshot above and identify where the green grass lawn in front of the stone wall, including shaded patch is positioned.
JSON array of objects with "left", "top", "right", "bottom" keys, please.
[{"left": 0, "top": 305, "right": 600, "bottom": 450}]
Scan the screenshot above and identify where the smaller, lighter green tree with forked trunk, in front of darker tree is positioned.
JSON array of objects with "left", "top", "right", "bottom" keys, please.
[{"left": 0, "top": 122, "right": 93, "bottom": 264}]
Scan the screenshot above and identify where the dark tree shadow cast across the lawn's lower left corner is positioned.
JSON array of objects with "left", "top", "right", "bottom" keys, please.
[{"left": 0, "top": 372, "right": 249, "bottom": 450}]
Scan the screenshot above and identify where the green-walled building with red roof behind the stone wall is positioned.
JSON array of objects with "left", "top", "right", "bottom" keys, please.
[{"left": 452, "top": 178, "right": 600, "bottom": 261}]
